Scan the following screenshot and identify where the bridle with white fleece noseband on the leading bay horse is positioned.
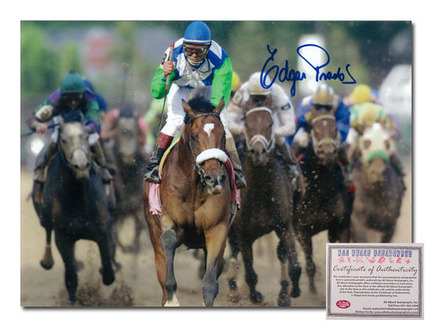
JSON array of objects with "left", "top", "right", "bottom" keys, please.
[{"left": 185, "top": 112, "right": 228, "bottom": 186}]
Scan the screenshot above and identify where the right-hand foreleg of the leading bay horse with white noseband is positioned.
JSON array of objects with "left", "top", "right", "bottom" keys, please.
[{"left": 202, "top": 224, "right": 228, "bottom": 307}]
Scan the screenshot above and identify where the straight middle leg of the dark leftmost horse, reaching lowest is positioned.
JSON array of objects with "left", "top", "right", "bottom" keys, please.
[{"left": 55, "top": 231, "right": 78, "bottom": 304}]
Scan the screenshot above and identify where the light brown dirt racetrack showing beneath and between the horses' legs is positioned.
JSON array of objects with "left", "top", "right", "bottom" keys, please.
[{"left": 21, "top": 163, "right": 412, "bottom": 307}]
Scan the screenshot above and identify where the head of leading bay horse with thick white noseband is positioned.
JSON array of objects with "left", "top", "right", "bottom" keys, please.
[{"left": 183, "top": 98, "right": 228, "bottom": 194}]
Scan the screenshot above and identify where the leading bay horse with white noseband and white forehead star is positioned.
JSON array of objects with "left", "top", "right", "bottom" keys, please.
[{"left": 144, "top": 94, "right": 233, "bottom": 306}]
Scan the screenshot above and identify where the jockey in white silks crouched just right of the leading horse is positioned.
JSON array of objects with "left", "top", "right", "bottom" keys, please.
[{"left": 227, "top": 72, "right": 300, "bottom": 191}]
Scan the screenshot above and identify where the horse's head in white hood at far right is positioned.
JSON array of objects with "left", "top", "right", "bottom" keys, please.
[{"left": 359, "top": 123, "right": 394, "bottom": 184}]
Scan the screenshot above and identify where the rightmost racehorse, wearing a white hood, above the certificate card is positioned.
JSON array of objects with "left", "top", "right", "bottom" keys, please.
[{"left": 351, "top": 123, "right": 403, "bottom": 243}]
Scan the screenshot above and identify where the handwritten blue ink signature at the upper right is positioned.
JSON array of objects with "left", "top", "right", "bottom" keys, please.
[{"left": 261, "top": 44, "right": 357, "bottom": 97}]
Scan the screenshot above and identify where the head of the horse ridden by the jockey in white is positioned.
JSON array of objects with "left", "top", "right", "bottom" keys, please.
[{"left": 244, "top": 106, "right": 275, "bottom": 166}]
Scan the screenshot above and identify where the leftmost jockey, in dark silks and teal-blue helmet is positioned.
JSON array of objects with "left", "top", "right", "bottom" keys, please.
[{"left": 27, "top": 72, "right": 112, "bottom": 202}]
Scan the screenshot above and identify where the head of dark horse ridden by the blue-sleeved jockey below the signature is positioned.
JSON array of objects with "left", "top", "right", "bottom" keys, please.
[{"left": 310, "top": 107, "right": 340, "bottom": 165}]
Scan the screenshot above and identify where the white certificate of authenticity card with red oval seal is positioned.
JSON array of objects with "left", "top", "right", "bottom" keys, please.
[{"left": 326, "top": 243, "right": 423, "bottom": 319}]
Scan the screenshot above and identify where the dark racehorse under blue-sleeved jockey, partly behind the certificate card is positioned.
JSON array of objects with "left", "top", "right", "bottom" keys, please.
[{"left": 294, "top": 108, "right": 352, "bottom": 293}]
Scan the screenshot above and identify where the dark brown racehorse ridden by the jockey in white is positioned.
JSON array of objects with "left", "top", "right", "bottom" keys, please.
[{"left": 227, "top": 100, "right": 301, "bottom": 306}]
